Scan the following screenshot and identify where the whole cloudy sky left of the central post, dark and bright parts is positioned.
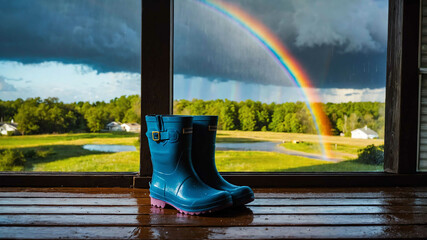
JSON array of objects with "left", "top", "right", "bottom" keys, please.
[{"left": 0, "top": 0, "right": 141, "bottom": 102}]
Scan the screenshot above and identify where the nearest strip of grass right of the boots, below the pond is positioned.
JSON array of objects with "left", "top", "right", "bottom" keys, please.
[{"left": 216, "top": 151, "right": 383, "bottom": 172}]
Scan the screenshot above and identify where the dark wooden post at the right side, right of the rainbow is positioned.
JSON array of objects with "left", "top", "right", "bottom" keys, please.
[{"left": 384, "top": 0, "right": 420, "bottom": 173}]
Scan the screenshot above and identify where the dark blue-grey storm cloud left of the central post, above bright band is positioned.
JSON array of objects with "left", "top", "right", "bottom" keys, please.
[{"left": 0, "top": 0, "right": 141, "bottom": 72}]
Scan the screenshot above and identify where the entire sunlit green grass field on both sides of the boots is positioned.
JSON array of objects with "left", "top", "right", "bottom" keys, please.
[{"left": 0, "top": 131, "right": 383, "bottom": 172}]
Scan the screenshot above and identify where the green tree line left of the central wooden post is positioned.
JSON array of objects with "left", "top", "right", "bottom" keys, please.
[{"left": 0, "top": 95, "right": 141, "bottom": 135}]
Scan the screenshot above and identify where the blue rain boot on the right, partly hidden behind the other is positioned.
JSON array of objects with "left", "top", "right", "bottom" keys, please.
[{"left": 191, "top": 116, "right": 254, "bottom": 205}]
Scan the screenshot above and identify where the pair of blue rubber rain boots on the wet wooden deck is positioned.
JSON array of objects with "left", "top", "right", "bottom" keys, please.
[{"left": 145, "top": 115, "right": 254, "bottom": 215}]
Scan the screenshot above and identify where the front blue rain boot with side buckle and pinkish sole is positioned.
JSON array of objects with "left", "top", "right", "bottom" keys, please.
[{"left": 145, "top": 115, "right": 233, "bottom": 215}]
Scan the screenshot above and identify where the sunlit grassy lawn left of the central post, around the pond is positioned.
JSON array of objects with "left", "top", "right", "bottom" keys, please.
[{"left": 0, "top": 132, "right": 139, "bottom": 172}]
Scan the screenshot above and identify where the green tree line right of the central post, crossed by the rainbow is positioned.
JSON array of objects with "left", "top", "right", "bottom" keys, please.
[{"left": 174, "top": 99, "right": 385, "bottom": 138}]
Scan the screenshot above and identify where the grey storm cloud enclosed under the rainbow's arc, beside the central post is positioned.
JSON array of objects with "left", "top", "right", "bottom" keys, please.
[{"left": 174, "top": 0, "right": 289, "bottom": 84}]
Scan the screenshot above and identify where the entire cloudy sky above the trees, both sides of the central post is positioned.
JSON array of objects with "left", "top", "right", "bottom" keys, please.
[{"left": 0, "top": 0, "right": 388, "bottom": 102}]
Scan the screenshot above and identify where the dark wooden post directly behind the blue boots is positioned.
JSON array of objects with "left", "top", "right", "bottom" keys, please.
[{"left": 140, "top": 0, "right": 173, "bottom": 176}]
